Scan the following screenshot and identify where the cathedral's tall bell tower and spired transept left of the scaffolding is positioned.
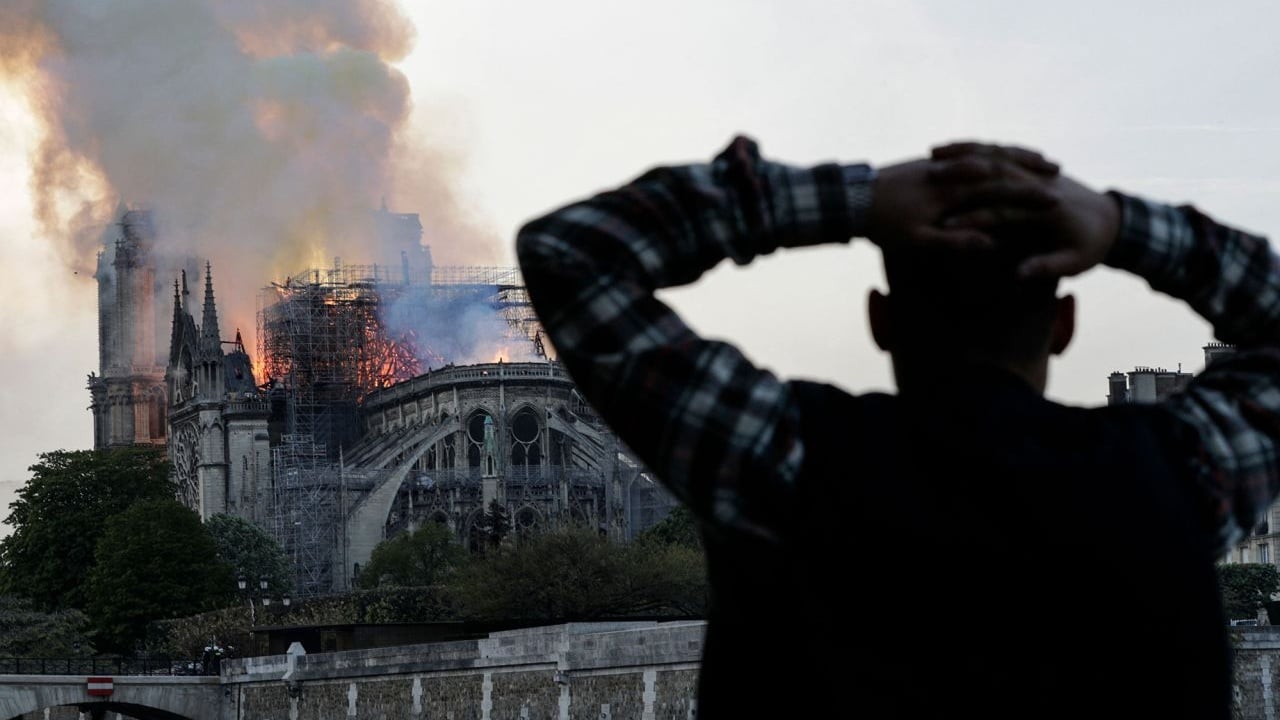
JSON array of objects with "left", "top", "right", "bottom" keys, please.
[{"left": 88, "top": 206, "right": 270, "bottom": 519}]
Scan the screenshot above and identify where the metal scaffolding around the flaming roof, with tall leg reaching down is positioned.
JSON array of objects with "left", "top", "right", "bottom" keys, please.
[{"left": 257, "top": 258, "right": 545, "bottom": 596}]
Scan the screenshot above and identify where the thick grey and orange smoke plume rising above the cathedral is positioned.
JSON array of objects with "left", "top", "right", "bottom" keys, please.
[{"left": 0, "top": 0, "right": 488, "bottom": 348}]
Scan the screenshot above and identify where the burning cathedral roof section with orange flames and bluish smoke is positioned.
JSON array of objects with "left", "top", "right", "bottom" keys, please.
[{"left": 257, "top": 254, "right": 544, "bottom": 446}]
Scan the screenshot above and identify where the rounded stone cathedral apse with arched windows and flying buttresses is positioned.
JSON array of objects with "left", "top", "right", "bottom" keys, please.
[{"left": 348, "top": 363, "right": 672, "bottom": 557}]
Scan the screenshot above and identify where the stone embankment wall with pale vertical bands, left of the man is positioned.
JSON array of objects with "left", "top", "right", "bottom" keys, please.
[{"left": 223, "top": 623, "right": 704, "bottom": 720}]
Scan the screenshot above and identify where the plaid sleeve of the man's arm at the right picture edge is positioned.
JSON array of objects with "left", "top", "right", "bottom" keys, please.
[{"left": 1107, "top": 193, "right": 1280, "bottom": 553}]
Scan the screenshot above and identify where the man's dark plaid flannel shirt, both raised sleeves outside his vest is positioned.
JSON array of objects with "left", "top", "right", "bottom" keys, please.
[{"left": 517, "top": 137, "right": 1280, "bottom": 556}]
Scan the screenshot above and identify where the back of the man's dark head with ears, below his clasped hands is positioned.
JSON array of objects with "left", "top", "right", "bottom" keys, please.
[{"left": 869, "top": 243, "right": 1075, "bottom": 392}]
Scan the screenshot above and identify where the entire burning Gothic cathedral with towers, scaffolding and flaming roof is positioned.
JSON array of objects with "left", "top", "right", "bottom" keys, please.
[{"left": 88, "top": 205, "right": 673, "bottom": 596}]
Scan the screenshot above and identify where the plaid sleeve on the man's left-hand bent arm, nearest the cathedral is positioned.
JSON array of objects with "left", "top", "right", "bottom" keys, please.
[{"left": 516, "top": 137, "right": 872, "bottom": 539}]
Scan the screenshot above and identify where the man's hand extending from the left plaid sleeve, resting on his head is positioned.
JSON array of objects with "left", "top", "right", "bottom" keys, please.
[{"left": 867, "top": 143, "right": 1057, "bottom": 250}]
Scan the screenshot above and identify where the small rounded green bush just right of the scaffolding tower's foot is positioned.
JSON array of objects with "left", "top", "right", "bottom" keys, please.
[{"left": 360, "top": 523, "right": 467, "bottom": 588}]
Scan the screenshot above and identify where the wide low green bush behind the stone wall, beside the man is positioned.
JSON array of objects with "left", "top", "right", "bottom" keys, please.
[{"left": 452, "top": 528, "right": 707, "bottom": 621}]
